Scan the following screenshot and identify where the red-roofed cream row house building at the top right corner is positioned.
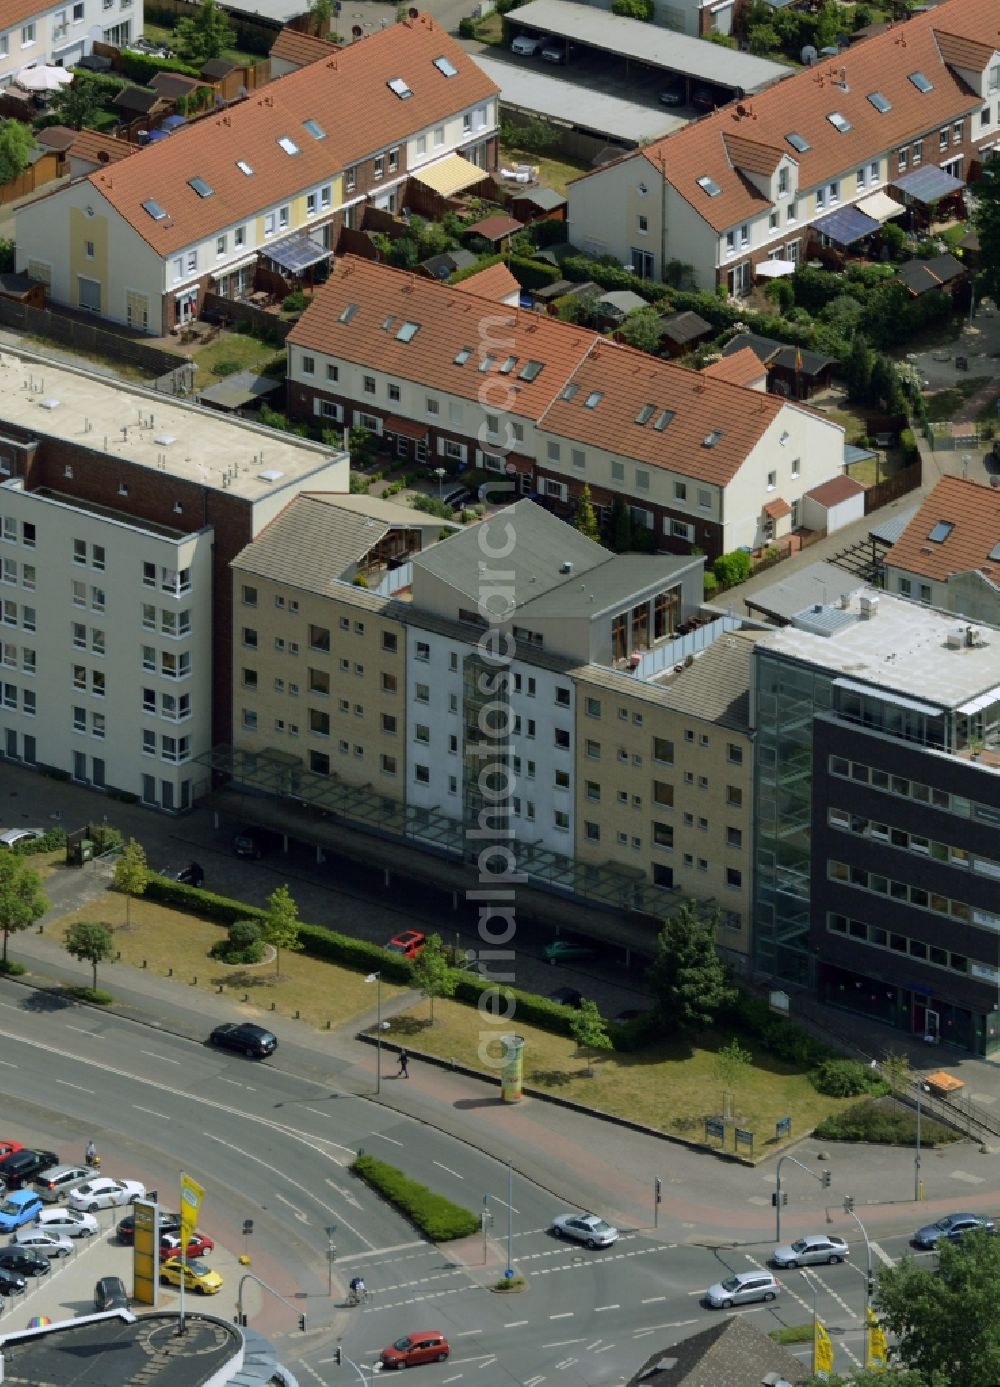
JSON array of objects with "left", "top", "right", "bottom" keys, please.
[{"left": 569, "top": 0, "right": 1000, "bottom": 294}]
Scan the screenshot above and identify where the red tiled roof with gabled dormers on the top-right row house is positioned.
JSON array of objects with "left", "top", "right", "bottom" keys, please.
[{"left": 626, "top": 0, "right": 1000, "bottom": 232}]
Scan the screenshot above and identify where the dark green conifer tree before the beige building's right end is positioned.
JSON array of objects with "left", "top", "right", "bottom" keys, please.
[{"left": 646, "top": 900, "right": 736, "bottom": 1031}]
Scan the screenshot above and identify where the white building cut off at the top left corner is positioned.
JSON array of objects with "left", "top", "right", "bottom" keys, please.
[{"left": 0, "top": 0, "right": 143, "bottom": 87}]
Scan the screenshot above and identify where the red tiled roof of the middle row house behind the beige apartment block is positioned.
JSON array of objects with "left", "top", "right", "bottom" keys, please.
[{"left": 288, "top": 255, "right": 804, "bottom": 485}]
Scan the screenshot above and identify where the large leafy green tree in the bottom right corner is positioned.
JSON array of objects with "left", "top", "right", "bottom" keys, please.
[{"left": 874, "top": 1230, "right": 1000, "bottom": 1387}]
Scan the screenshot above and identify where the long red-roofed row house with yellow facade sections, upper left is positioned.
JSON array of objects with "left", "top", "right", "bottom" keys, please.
[{"left": 17, "top": 15, "right": 497, "bottom": 336}]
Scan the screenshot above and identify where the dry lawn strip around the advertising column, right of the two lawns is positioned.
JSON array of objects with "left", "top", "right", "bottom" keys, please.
[{"left": 388, "top": 1000, "right": 850, "bottom": 1154}]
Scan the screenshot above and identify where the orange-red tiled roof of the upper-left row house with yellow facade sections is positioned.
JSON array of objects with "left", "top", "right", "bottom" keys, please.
[{"left": 90, "top": 14, "right": 498, "bottom": 255}]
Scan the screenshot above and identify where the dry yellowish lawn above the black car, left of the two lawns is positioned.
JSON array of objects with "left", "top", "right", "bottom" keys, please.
[{"left": 46, "top": 892, "right": 405, "bottom": 1029}]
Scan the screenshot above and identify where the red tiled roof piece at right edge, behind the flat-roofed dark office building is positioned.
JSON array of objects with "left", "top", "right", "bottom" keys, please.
[{"left": 885, "top": 477, "right": 1000, "bottom": 583}]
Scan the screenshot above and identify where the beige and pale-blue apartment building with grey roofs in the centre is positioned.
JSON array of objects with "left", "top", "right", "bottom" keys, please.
[{"left": 226, "top": 498, "right": 752, "bottom": 956}]
